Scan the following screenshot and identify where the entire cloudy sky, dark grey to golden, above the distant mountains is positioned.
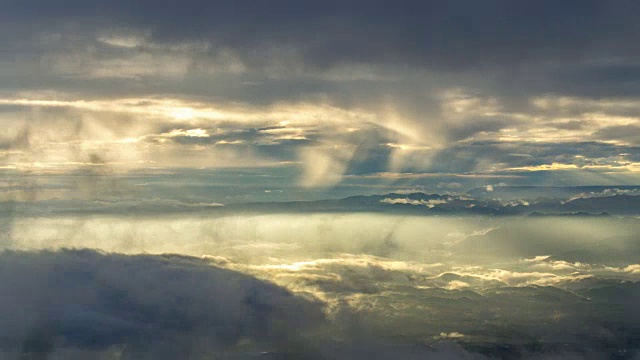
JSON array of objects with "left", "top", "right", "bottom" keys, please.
[{"left": 0, "top": 0, "right": 640, "bottom": 202}]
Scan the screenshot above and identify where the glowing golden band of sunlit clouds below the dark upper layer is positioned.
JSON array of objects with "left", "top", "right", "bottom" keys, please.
[{"left": 0, "top": 88, "right": 640, "bottom": 183}]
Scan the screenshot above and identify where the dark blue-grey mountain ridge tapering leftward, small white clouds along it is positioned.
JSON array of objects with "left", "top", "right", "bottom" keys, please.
[{"left": 234, "top": 186, "right": 640, "bottom": 216}]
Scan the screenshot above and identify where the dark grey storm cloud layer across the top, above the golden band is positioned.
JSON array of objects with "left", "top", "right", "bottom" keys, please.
[{"left": 0, "top": 0, "right": 640, "bottom": 106}]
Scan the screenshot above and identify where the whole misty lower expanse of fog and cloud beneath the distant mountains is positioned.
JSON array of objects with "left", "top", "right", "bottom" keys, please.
[{"left": 0, "top": 214, "right": 640, "bottom": 359}]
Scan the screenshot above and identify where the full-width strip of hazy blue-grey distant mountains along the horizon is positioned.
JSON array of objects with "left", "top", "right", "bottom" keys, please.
[{"left": 0, "top": 186, "right": 640, "bottom": 217}]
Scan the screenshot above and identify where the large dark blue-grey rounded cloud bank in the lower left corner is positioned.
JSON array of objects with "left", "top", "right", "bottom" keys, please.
[{"left": 0, "top": 250, "right": 323, "bottom": 359}]
